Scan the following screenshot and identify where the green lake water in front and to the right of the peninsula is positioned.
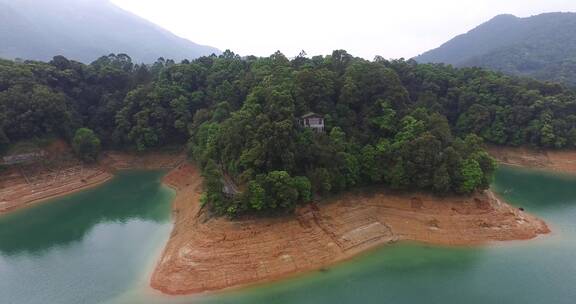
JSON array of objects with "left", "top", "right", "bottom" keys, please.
[{"left": 113, "top": 168, "right": 576, "bottom": 304}]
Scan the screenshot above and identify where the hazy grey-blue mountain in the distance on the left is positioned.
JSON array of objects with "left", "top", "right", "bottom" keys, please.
[{"left": 0, "top": 0, "right": 220, "bottom": 63}]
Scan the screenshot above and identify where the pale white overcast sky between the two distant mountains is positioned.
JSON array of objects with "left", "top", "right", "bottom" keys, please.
[{"left": 111, "top": 0, "right": 576, "bottom": 59}]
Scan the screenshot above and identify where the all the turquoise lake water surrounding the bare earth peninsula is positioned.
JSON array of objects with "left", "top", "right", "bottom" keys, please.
[{"left": 0, "top": 168, "right": 576, "bottom": 304}]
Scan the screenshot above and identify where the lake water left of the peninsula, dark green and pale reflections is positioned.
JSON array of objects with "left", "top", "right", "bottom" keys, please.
[{"left": 0, "top": 171, "right": 173, "bottom": 304}]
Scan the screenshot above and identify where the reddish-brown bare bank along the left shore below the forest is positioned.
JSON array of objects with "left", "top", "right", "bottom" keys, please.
[{"left": 0, "top": 151, "right": 185, "bottom": 214}]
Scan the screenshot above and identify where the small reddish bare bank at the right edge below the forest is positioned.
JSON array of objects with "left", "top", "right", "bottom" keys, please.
[{"left": 488, "top": 146, "right": 576, "bottom": 173}]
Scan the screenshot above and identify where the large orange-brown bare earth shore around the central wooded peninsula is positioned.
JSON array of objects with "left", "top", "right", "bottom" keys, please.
[{"left": 151, "top": 164, "right": 549, "bottom": 295}]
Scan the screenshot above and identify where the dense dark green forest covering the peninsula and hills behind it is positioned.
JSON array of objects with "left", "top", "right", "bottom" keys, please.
[{"left": 0, "top": 50, "right": 576, "bottom": 215}]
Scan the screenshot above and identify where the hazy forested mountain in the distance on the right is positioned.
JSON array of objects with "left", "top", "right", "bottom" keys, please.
[{"left": 414, "top": 13, "right": 576, "bottom": 86}]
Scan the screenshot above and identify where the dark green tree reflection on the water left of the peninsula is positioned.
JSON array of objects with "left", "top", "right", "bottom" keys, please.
[{"left": 0, "top": 171, "right": 173, "bottom": 255}]
